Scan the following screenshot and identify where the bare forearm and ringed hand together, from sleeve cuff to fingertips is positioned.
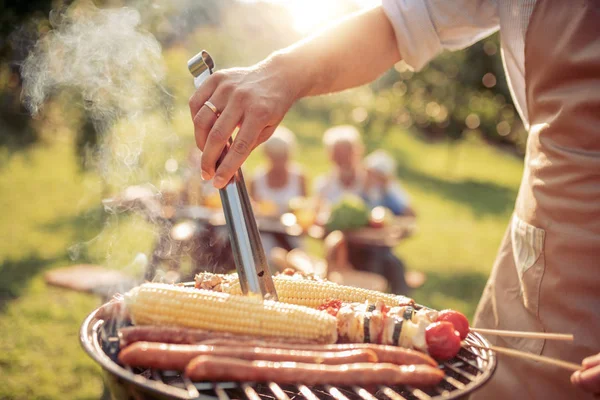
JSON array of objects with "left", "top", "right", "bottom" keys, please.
[{"left": 190, "top": 6, "right": 400, "bottom": 188}]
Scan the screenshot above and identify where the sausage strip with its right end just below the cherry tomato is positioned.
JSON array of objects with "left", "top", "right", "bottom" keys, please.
[{"left": 197, "top": 338, "right": 437, "bottom": 367}]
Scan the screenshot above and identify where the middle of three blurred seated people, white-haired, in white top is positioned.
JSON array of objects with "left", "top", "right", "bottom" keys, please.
[{"left": 315, "top": 125, "right": 365, "bottom": 205}]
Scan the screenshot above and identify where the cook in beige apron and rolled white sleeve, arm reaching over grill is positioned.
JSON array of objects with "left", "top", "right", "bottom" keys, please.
[{"left": 190, "top": 0, "right": 600, "bottom": 399}]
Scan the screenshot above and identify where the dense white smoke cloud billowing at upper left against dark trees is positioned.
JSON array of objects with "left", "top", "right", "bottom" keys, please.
[{"left": 22, "top": 0, "right": 172, "bottom": 187}]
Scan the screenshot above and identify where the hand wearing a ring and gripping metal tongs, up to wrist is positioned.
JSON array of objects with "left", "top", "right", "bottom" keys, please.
[{"left": 189, "top": 59, "right": 299, "bottom": 188}]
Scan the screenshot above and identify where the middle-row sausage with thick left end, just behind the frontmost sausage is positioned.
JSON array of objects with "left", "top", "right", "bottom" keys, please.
[{"left": 119, "top": 342, "right": 377, "bottom": 371}]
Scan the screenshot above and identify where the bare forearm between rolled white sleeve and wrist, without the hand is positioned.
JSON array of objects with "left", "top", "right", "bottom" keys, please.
[{"left": 266, "top": 6, "right": 400, "bottom": 98}]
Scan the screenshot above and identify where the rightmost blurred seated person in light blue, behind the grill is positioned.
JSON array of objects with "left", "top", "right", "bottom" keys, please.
[{"left": 362, "top": 150, "right": 415, "bottom": 216}]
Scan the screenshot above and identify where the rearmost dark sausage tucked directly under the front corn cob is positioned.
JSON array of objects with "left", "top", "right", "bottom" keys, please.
[{"left": 119, "top": 325, "right": 314, "bottom": 347}]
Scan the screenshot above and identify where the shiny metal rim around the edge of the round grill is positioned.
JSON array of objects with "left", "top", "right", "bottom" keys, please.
[{"left": 79, "top": 305, "right": 498, "bottom": 400}]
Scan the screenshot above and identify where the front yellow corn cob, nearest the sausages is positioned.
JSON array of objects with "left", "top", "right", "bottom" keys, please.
[{"left": 124, "top": 283, "right": 337, "bottom": 343}]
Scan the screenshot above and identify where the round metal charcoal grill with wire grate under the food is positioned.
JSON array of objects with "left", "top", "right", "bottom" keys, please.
[{"left": 80, "top": 304, "right": 496, "bottom": 400}]
